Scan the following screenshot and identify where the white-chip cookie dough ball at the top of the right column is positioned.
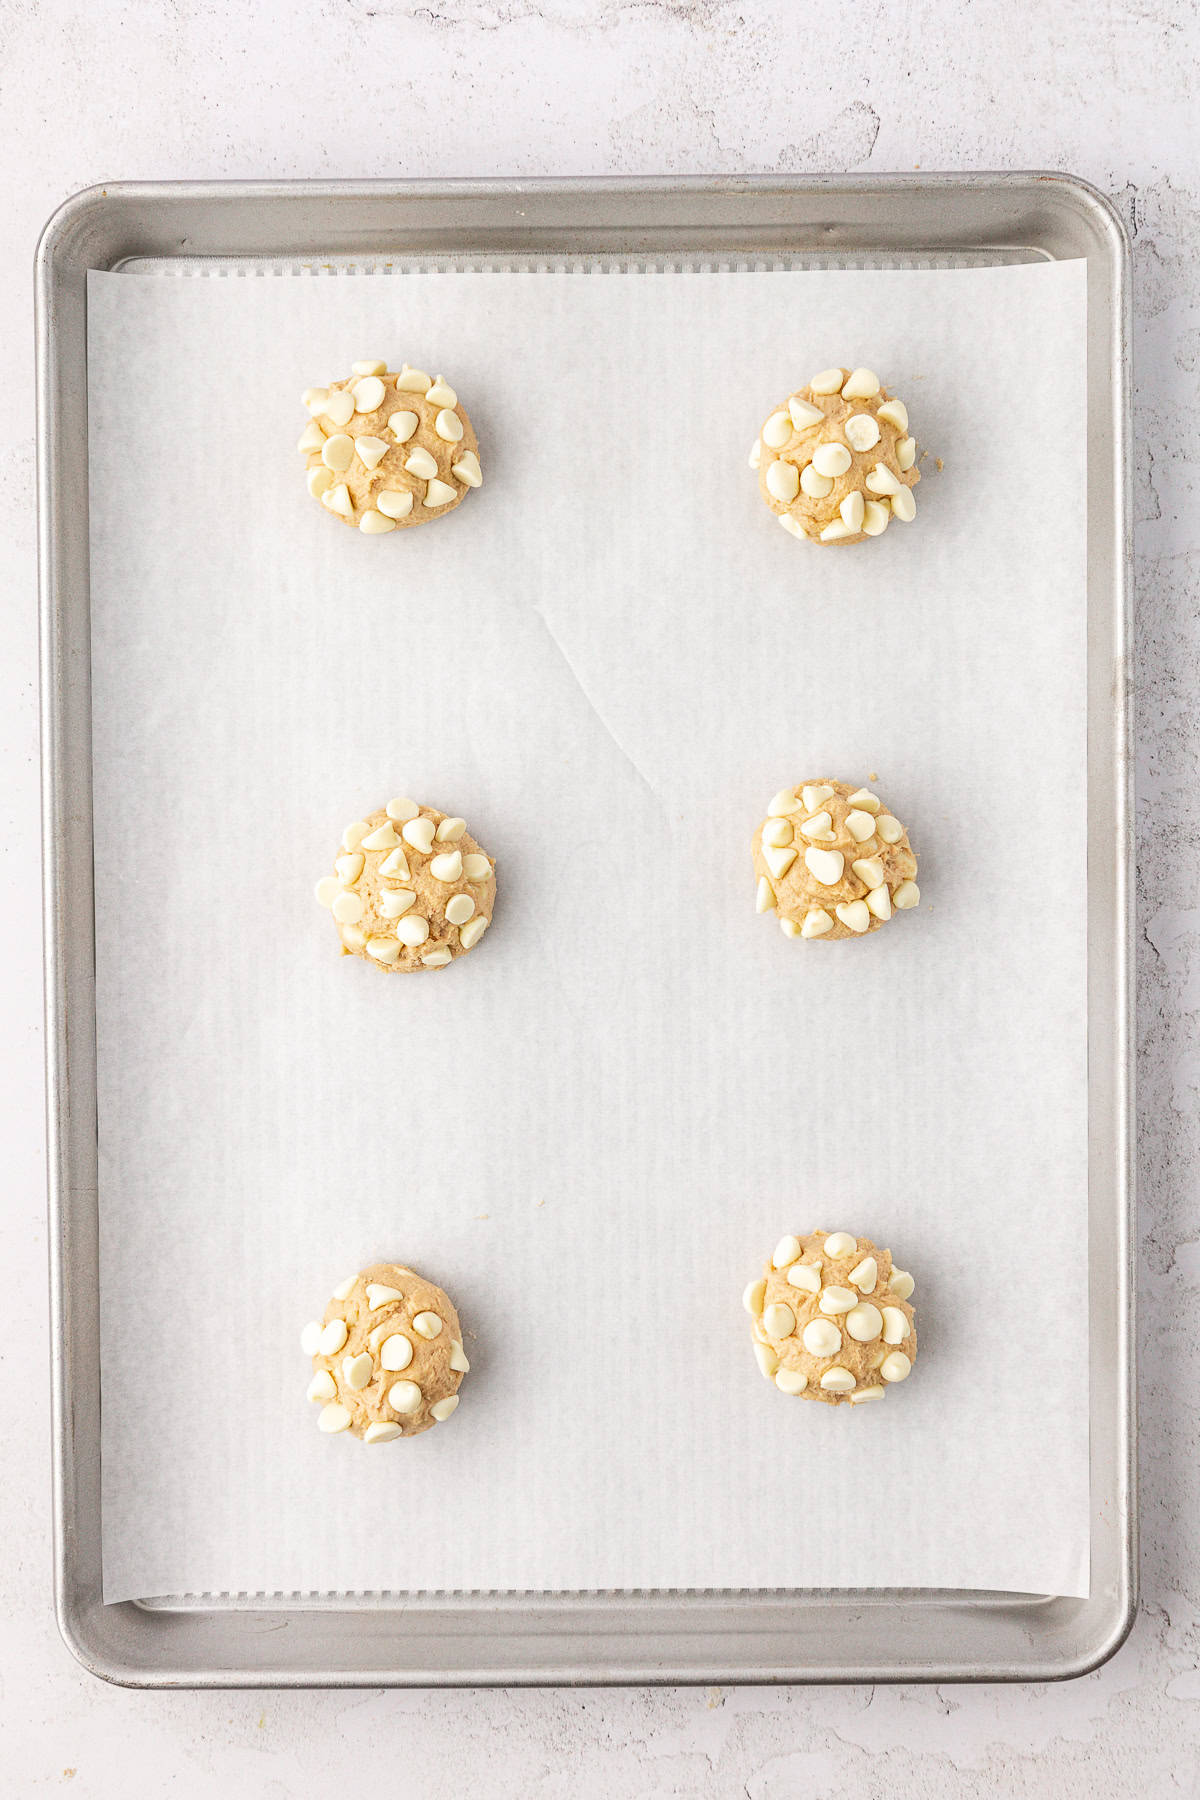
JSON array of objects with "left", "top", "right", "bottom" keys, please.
[{"left": 750, "top": 369, "right": 921, "bottom": 544}]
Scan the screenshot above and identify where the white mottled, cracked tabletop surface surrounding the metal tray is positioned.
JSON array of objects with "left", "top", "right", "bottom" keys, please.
[{"left": 0, "top": 0, "right": 1200, "bottom": 1800}]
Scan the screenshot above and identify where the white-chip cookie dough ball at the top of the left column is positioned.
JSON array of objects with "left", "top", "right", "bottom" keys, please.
[{"left": 297, "top": 362, "right": 484, "bottom": 538}]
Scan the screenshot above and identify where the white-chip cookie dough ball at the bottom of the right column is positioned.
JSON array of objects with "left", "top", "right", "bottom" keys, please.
[{"left": 743, "top": 1231, "right": 918, "bottom": 1406}]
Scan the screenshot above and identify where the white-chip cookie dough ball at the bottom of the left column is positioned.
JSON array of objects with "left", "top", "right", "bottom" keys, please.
[{"left": 300, "top": 1262, "right": 471, "bottom": 1444}]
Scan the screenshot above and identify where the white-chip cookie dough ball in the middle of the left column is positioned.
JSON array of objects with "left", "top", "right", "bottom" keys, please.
[{"left": 317, "top": 799, "right": 497, "bottom": 972}]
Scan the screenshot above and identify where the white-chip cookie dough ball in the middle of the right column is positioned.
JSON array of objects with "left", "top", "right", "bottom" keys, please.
[{"left": 754, "top": 781, "right": 921, "bottom": 940}]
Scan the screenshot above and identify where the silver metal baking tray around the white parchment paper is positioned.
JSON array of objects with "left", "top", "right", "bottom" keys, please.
[{"left": 38, "top": 175, "right": 1137, "bottom": 1687}]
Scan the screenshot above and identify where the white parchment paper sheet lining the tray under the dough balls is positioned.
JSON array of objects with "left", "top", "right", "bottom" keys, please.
[{"left": 88, "top": 263, "right": 1088, "bottom": 1600}]
